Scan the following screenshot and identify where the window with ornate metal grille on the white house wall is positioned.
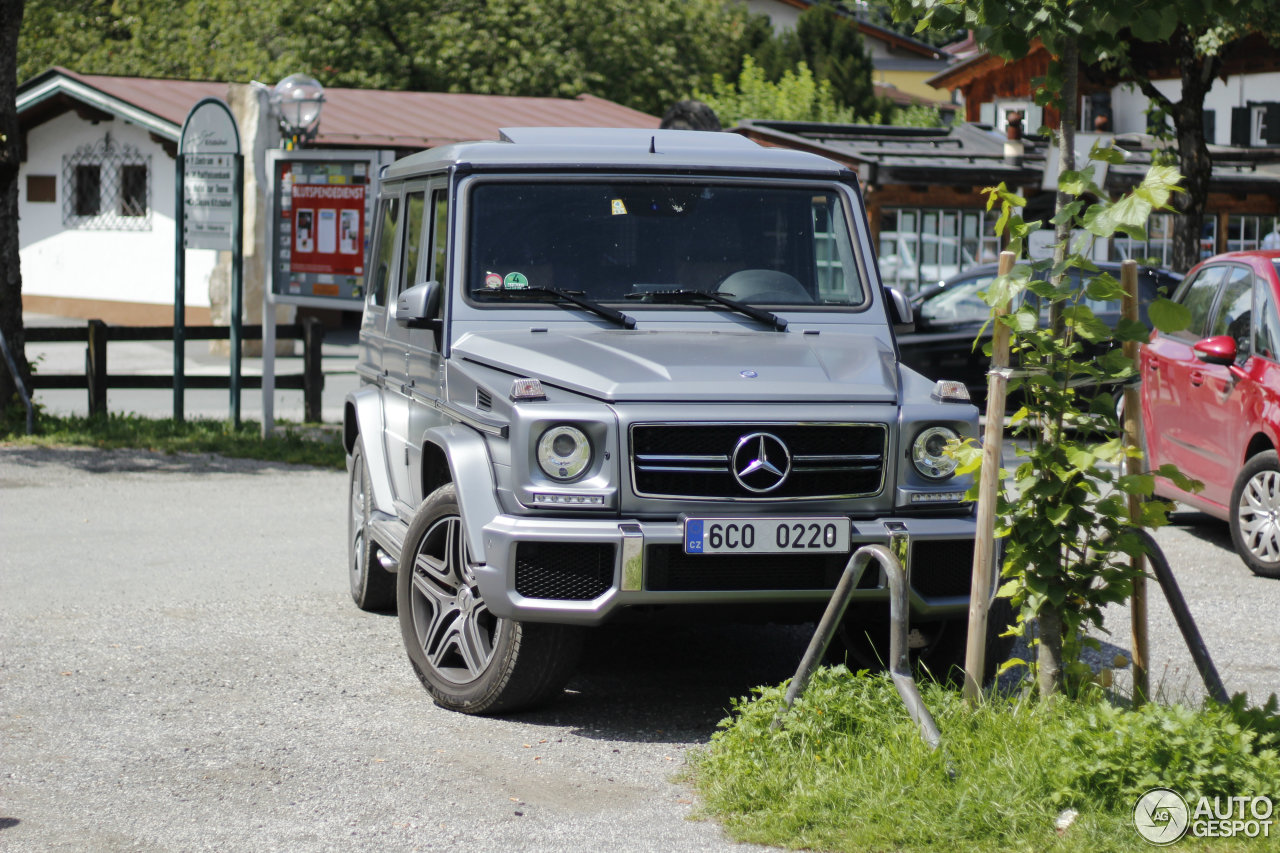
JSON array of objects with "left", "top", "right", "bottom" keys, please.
[{"left": 63, "top": 133, "right": 151, "bottom": 231}]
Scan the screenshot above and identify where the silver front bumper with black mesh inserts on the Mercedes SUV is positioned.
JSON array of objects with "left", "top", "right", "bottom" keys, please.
[{"left": 475, "top": 515, "right": 975, "bottom": 625}]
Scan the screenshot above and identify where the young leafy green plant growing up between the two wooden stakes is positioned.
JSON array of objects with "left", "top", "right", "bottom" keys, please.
[{"left": 957, "top": 150, "right": 1193, "bottom": 697}]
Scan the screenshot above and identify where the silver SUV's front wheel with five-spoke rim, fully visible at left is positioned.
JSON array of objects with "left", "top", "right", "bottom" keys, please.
[{"left": 396, "top": 483, "right": 584, "bottom": 713}]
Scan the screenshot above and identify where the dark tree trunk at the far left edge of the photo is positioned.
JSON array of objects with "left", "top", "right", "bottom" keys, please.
[{"left": 0, "top": 0, "right": 31, "bottom": 412}]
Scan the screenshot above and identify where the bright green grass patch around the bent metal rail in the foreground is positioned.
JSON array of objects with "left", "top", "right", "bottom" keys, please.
[{"left": 690, "top": 667, "right": 1280, "bottom": 852}]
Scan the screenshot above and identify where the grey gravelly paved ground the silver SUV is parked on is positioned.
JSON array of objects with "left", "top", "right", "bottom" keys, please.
[{"left": 0, "top": 447, "right": 1280, "bottom": 853}]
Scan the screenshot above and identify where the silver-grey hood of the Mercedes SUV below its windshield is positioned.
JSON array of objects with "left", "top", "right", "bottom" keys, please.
[{"left": 452, "top": 329, "right": 899, "bottom": 402}]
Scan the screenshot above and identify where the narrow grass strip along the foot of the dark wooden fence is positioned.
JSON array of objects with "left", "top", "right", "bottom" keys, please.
[{"left": 0, "top": 409, "right": 346, "bottom": 469}]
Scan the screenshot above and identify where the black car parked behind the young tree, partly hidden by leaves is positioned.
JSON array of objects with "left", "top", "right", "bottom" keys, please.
[{"left": 897, "top": 263, "right": 1183, "bottom": 401}]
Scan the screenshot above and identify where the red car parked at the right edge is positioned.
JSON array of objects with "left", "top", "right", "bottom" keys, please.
[{"left": 1142, "top": 251, "right": 1280, "bottom": 578}]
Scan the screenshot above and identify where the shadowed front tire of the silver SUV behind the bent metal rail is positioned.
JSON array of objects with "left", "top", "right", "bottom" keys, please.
[{"left": 832, "top": 598, "right": 1014, "bottom": 684}]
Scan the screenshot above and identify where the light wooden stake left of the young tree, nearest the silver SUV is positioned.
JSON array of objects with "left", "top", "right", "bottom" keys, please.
[{"left": 964, "top": 252, "right": 1015, "bottom": 704}]
